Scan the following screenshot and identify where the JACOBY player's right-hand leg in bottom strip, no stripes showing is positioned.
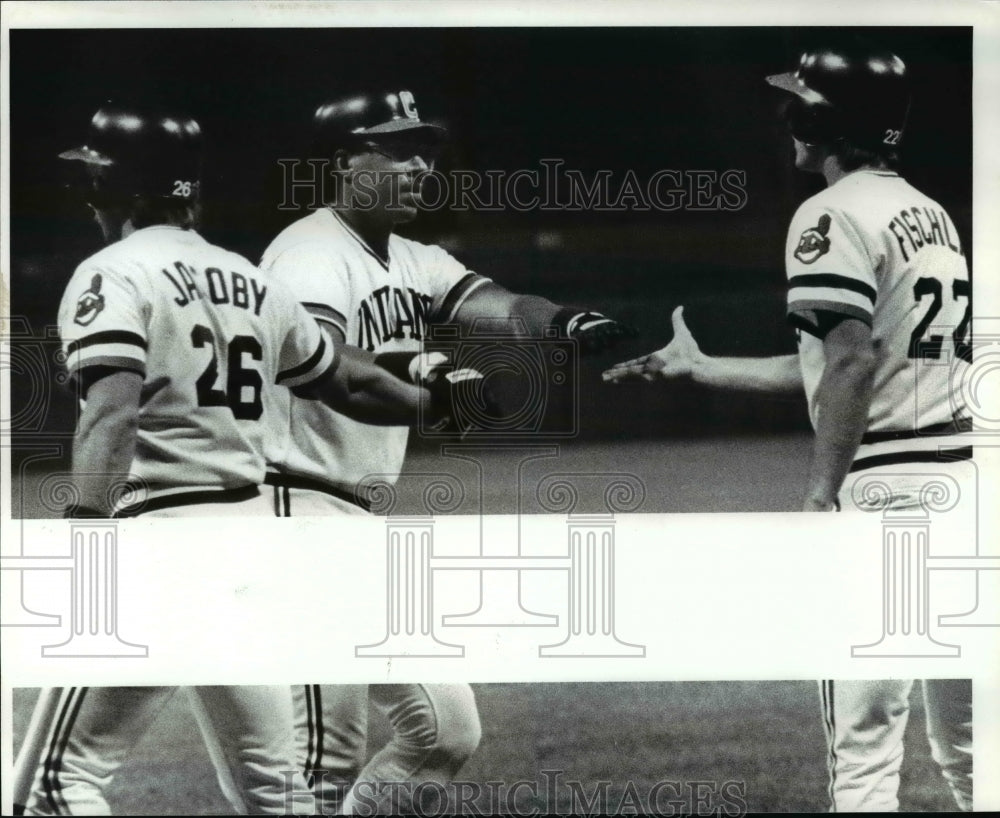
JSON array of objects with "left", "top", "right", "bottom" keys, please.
[{"left": 188, "top": 685, "right": 315, "bottom": 815}]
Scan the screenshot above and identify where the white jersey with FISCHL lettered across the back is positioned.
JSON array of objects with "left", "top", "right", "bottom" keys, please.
[{"left": 785, "top": 170, "right": 972, "bottom": 469}]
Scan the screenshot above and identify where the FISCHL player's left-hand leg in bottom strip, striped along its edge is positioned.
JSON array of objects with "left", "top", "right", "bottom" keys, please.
[{"left": 820, "top": 679, "right": 913, "bottom": 812}]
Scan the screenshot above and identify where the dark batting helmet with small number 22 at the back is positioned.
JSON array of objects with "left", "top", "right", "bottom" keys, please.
[{"left": 767, "top": 46, "right": 910, "bottom": 151}]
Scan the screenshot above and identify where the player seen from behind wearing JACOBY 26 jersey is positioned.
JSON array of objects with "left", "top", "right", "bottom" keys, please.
[{"left": 21, "top": 106, "right": 450, "bottom": 815}]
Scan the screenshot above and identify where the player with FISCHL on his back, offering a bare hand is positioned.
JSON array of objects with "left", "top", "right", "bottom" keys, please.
[{"left": 605, "top": 45, "right": 972, "bottom": 811}]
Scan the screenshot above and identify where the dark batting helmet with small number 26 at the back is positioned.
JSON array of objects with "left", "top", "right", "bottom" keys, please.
[{"left": 59, "top": 105, "right": 202, "bottom": 199}]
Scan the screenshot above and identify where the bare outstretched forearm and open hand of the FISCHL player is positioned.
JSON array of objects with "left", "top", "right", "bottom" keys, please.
[{"left": 604, "top": 307, "right": 803, "bottom": 395}]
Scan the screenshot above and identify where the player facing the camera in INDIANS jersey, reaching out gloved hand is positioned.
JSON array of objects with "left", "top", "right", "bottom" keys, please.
[{"left": 261, "top": 90, "right": 631, "bottom": 814}]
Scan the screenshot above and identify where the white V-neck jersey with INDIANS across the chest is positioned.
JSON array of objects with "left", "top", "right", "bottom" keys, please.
[{"left": 261, "top": 208, "right": 488, "bottom": 497}]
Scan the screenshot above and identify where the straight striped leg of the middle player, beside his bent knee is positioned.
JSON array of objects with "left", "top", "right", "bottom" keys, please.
[{"left": 292, "top": 685, "right": 368, "bottom": 815}]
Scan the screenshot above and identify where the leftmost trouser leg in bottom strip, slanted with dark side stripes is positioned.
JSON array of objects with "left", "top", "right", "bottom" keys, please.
[{"left": 27, "top": 687, "right": 176, "bottom": 815}]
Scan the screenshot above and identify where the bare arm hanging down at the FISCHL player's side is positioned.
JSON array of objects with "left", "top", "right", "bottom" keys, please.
[{"left": 803, "top": 357, "right": 874, "bottom": 511}]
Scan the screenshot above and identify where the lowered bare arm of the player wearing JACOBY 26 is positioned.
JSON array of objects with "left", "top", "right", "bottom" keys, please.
[{"left": 67, "top": 370, "right": 142, "bottom": 517}]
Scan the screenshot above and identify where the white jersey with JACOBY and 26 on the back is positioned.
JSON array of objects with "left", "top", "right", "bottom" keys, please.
[{"left": 59, "top": 225, "right": 334, "bottom": 510}]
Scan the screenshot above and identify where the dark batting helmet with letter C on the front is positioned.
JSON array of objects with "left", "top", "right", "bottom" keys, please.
[{"left": 313, "top": 91, "right": 448, "bottom": 153}]
